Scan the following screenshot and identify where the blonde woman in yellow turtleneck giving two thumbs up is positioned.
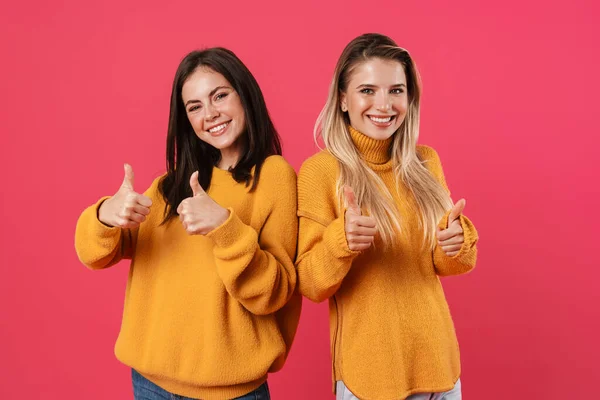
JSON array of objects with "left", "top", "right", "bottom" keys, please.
[{"left": 296, "top": 34, "right": 478, "bottom": 400}]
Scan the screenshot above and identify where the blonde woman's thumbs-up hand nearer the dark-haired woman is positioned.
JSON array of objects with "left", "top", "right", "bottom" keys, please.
[{"left": 344, "top": 186, "right": 377, "bottom": 251}]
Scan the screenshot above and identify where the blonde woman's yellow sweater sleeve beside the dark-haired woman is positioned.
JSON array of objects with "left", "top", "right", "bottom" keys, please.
[{"left": 296, "top": 156, "right": 360, "bottom": 302}]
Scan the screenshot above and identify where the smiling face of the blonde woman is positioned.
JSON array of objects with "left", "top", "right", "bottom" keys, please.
[{"left": 340, "top": 58, "right": 408, "bottom": 140}]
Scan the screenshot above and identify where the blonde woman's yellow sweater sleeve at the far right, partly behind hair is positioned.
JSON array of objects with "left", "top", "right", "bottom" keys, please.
[{"left": 420, "top": 146, "right": 479, "bottom": 276}]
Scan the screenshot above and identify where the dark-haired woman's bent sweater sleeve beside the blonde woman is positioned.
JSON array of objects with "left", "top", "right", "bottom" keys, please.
[{"left": 207, "top": 157, "right": 298, "bottom": 315}]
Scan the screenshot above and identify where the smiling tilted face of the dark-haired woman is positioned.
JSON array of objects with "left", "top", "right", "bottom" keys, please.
[{"left": 181, "top": 67, "right": 246, "bottom": 156}]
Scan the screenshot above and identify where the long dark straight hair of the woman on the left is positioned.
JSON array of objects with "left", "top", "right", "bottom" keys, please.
[{"left": 159, "top": 47, "right": 281, "bottom": 223}]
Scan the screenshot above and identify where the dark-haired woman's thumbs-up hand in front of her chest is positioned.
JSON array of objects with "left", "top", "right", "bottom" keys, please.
[{"left": 177, "top": 171, "right": 229, "bottom": 235}]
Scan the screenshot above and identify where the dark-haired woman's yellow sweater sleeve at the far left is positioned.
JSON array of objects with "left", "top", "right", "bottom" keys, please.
[{"left": 75, "top": 197, "right": 138, "bottom": 269}]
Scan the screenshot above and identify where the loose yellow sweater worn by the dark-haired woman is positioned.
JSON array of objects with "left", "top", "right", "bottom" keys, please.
[{"left": 75, "top": 156, "right": 301, "bottom": 399}]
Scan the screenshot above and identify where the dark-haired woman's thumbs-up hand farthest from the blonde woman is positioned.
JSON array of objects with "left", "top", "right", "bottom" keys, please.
[{"left": 98, "top": 164, "right": 152, "bottom": 228}]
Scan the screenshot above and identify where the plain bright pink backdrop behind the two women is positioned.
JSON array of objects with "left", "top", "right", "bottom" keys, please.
[{"left": 0, "top": 0, "right": 600, "bottom": 400}]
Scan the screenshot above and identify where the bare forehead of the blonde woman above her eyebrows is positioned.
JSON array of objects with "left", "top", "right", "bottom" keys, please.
[{"left": 350, "top": 58, "right": 406, "bottom": 87}]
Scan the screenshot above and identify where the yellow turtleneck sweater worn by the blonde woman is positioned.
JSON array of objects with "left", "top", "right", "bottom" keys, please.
[{"left": 296, "top": 129, "right": 478, "bottom": 400}]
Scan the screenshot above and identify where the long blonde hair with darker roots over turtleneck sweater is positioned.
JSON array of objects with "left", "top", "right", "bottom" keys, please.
[{"left": 314, "top": 33, "right": 452, "bottom": 248}]
